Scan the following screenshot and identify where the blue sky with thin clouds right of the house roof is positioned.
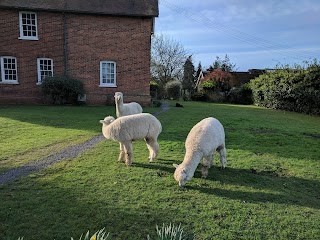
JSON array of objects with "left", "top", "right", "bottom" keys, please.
[{"left": 155, "top": 0, "right": 320, "bottom": 71}]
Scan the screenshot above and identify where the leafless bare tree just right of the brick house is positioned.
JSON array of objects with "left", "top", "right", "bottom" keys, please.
[{"left": 150, "top": 34, "right": 188, "bottom": 86}]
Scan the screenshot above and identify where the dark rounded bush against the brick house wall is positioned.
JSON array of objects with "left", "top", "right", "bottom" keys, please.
[{"left": 41, "top": 76, "right": 84, "bottom": 104}]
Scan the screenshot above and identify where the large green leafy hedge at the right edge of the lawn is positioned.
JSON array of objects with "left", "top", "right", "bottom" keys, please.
[{"left": 250, "top": 60, "right": 320, "bottom": 114}]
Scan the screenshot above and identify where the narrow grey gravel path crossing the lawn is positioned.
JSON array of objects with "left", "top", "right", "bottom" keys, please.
[{"left": 0, "top": 103, "right": 170, "bottom": 186}]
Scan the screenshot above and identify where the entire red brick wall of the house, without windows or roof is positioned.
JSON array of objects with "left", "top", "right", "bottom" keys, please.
[{"left": 0, "top": 9, "right": 152, "bottom": 105}]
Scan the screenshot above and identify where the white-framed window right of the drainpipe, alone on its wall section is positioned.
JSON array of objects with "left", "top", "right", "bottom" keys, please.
[{"left": 100, "top": 61, "right": 117, "bottom": 87}]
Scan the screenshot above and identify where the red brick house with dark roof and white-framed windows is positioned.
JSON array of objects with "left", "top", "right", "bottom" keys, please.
[{"left": 0, "top": 0, "right": 159, "bottom": 105}]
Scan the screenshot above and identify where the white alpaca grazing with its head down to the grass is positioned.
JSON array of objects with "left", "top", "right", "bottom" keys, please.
[{"left": 173, "top": 117, "right": 227, "bottom": 186}]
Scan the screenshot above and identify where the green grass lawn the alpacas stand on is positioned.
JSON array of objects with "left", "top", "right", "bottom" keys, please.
[{"left": 0, "top": 102, "right": 320, "bottom": 240}]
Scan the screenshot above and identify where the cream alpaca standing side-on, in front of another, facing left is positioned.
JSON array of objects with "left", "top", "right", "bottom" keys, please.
[{"left": 100, "top": 113, "right": 162, "bottom": 166}]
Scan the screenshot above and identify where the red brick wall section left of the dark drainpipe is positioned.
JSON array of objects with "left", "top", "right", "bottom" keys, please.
[{"left": 0, "top": 9, "right": 63, "bottom": 104}]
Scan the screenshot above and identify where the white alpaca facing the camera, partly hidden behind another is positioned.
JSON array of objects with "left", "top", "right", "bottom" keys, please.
[{"left": 114, "top": 92, "right": 142, "bottom": 117}]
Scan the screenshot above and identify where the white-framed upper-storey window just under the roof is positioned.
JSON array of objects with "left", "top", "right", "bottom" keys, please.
[{"left": 19, "top": 12, "right": 38, "bottom": 40}]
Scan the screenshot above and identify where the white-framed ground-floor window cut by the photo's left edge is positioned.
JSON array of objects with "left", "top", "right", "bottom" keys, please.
[{"left": 1, "top": 57, "right": 18, "bottom": 84}]
